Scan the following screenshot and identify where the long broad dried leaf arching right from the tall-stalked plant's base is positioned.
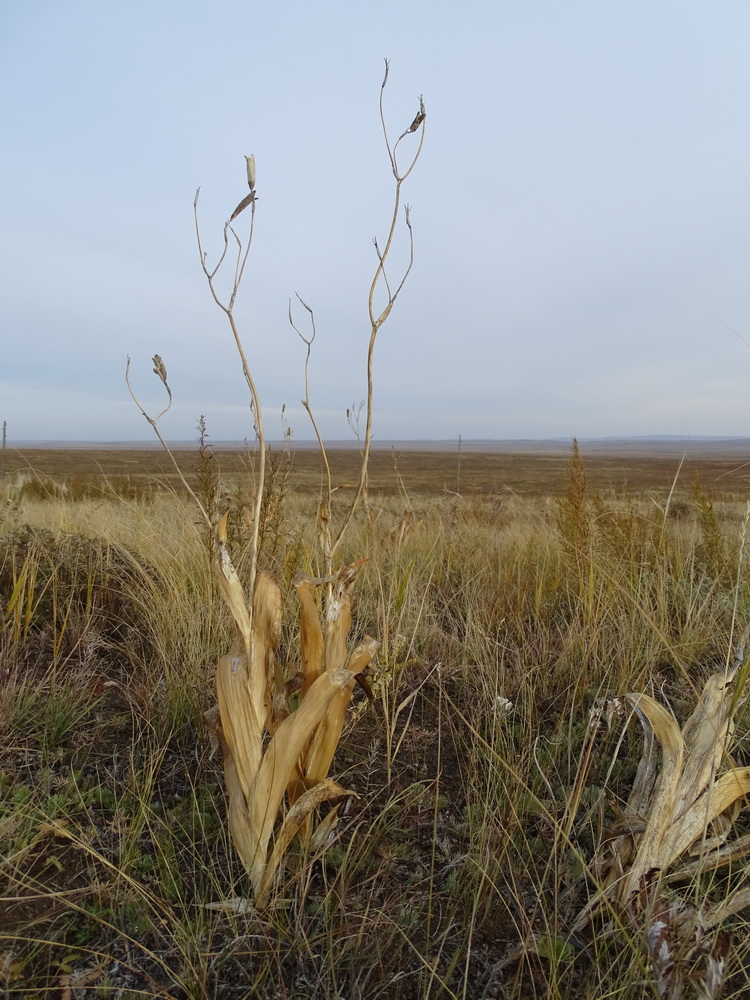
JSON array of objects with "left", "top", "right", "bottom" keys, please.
[{"left": 248, "top": 670, "right": 353, "bottom": 884}]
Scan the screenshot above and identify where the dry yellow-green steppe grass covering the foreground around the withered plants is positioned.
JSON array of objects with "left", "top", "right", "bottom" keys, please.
[{"left": 0, "top": 455, "right": 750, "bottom": 1000}]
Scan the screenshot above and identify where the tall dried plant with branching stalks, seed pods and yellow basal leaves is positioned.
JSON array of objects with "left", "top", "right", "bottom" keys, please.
[{"left": 132, "top": 63, "right": 425, "bottom": 906}]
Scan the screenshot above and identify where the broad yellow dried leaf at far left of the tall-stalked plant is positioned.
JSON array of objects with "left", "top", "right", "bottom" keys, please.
[{"left": 216, "top": 653, "right": 263, "bottom": 796}]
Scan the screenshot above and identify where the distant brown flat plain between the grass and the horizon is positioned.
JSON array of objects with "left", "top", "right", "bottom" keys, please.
[{"left": 5, "top": 439, "right": 750, "bottom": 499}]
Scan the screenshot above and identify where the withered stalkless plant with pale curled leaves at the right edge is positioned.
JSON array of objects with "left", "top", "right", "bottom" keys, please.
[{"left": 573, "top": 630, "right": 750, "bottom": 1000}]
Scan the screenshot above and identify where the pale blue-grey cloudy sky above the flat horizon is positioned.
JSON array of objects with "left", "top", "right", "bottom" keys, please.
[{"left": 0, "top": 0, "right": 750, "bottom": 444}]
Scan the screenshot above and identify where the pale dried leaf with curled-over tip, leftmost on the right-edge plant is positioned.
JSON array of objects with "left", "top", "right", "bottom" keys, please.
[{"left": 620, "top": 694, "right": 684, "bottom": 899}]
